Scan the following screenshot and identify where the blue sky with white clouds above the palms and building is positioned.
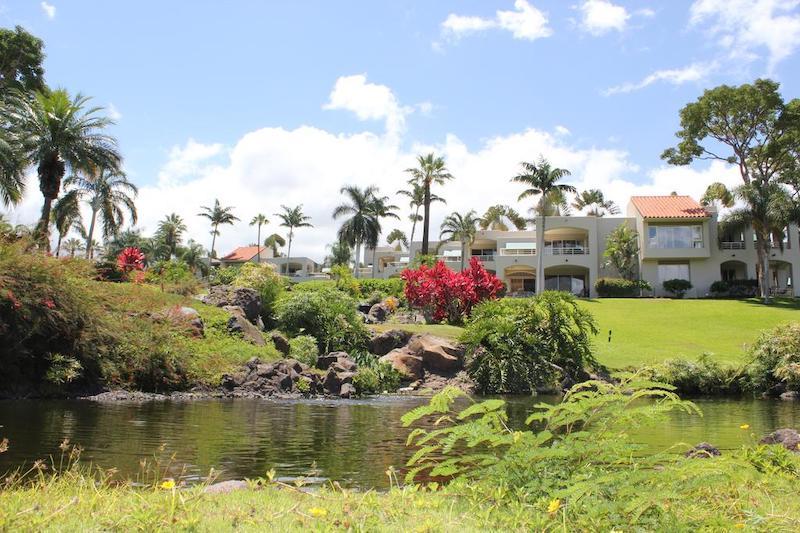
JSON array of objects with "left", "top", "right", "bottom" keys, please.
[{"left": 0, "top": 0, "right": 800, "bottom": 260}]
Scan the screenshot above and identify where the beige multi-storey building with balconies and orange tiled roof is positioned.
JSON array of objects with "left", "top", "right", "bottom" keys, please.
[{"left": 360, "top": 195, "right": 800, "bottom": 297}]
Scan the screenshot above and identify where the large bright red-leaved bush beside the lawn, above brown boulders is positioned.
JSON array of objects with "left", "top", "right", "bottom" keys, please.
[{"left": 402, "top": 257, "right": 503, "bottom": 324}]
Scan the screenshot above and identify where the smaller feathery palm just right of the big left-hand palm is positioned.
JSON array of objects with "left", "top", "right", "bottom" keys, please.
[{"left": 64, "top": 167, "right": 139, "bottom": 258}]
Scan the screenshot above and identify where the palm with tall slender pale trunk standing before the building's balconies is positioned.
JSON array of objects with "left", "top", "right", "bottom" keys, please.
[{"left": 511, "top": 156, "right": 575, "bottom": 294}]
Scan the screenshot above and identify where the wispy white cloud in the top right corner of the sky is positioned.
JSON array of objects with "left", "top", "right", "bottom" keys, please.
[{"left": 689, "top": 0, "right": 800, "bottom": 71}]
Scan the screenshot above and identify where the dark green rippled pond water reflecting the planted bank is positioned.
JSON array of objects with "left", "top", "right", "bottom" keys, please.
[{"left": 0, "top": 397, "right": 800, "bottom": 488}]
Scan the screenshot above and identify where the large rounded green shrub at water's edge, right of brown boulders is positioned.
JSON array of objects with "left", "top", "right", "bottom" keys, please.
[{"left": 461, "top": 291, "right": 597, "bottom": 393}]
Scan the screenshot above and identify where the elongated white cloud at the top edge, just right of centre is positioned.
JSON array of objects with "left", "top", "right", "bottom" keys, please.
[{"left": 433, "top": 0, "right": 553, "bottom": 42}]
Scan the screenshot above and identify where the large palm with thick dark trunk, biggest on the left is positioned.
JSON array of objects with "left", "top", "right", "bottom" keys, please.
[{"left": 3, "top": 89, "right": 122, "bottom": 250}]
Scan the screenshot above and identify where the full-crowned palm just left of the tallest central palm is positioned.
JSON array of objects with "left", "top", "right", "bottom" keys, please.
[{"left": 333, "top": 185, "right": 380, "bottom": 277}]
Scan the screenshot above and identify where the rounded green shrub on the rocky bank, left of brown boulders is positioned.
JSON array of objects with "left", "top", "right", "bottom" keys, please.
[{"left": 276, "top": 288, "right": 369, "bottom": 353}]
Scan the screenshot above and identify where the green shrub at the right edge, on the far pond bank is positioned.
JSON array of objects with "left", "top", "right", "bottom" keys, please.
[{"left": 746, "top": 322, "right": 800, "bottom": 394}]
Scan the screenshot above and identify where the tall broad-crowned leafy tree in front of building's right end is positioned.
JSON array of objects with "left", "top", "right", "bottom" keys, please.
[{"left": 661, "top": 79, "right": 800, "bottom": 302}]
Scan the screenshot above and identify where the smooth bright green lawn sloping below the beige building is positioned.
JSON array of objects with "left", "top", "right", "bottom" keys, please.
[{"left": 580, "top": 298, "right": 800, "bottom": 368}]
